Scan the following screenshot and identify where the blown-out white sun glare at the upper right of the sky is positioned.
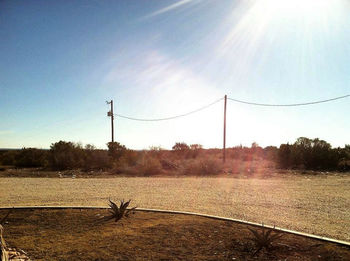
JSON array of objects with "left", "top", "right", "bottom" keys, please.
[{"left": 217, "top": 0, "right": 347, "bottom": 78}]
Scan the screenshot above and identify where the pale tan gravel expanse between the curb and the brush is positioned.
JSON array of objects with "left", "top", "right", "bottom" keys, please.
[{"left": 0, "top": 174, "right": 350, "bottom": 241}]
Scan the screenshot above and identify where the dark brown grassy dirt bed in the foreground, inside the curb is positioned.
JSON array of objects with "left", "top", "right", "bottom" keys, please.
[{"left": 0, "top": 209, "right": 350, "bottom": 261}]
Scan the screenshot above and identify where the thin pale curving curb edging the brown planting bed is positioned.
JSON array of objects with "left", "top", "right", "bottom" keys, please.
[{"left": 0, "top": 206, "right": 350, "bottom": 247}]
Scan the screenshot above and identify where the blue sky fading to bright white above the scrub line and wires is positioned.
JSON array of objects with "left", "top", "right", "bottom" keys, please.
[{"left": 0, "top": 0, "right": 350, "bottom": 149}]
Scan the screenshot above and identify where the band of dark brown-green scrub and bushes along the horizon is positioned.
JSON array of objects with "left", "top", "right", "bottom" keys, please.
[{"left": 0, "top": 137, "right": 350, "bottom": 173}]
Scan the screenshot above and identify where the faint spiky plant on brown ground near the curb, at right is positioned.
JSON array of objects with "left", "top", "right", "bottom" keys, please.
[{"left": 248, "top": 225, "right": 283, "bottom": 256}]
